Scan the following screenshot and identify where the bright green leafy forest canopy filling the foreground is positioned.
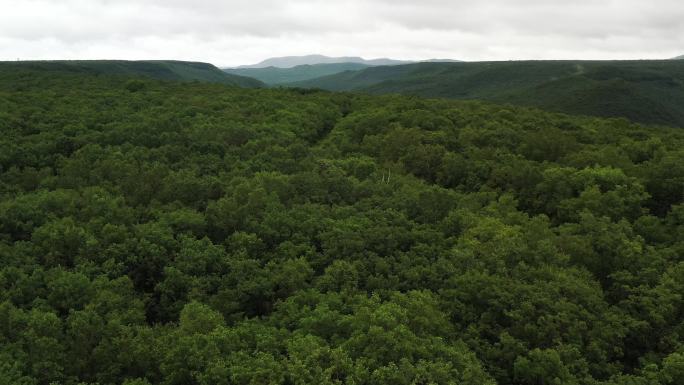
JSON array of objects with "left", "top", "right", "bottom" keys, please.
[{"left": 0, "top": 70, "right": 684, "bottom": 385}]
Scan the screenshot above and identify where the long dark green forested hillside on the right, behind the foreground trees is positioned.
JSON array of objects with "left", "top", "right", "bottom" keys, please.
[{"left": 292, "top": 60, "right": 684, "bottom": 127}]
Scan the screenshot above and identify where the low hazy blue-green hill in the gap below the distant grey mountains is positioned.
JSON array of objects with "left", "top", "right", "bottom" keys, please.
[{"left": 224, "top": 63, "right": 368, "bottom": 85}]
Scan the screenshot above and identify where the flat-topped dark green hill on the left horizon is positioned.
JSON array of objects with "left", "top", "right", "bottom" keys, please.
[{"left": 0, "top": 60, "right": 264, "bottom": 88}]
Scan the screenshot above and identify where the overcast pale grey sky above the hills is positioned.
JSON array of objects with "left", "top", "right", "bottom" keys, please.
[{"left": 0, "top": 0, "right": 684, "bottom": 66}]
